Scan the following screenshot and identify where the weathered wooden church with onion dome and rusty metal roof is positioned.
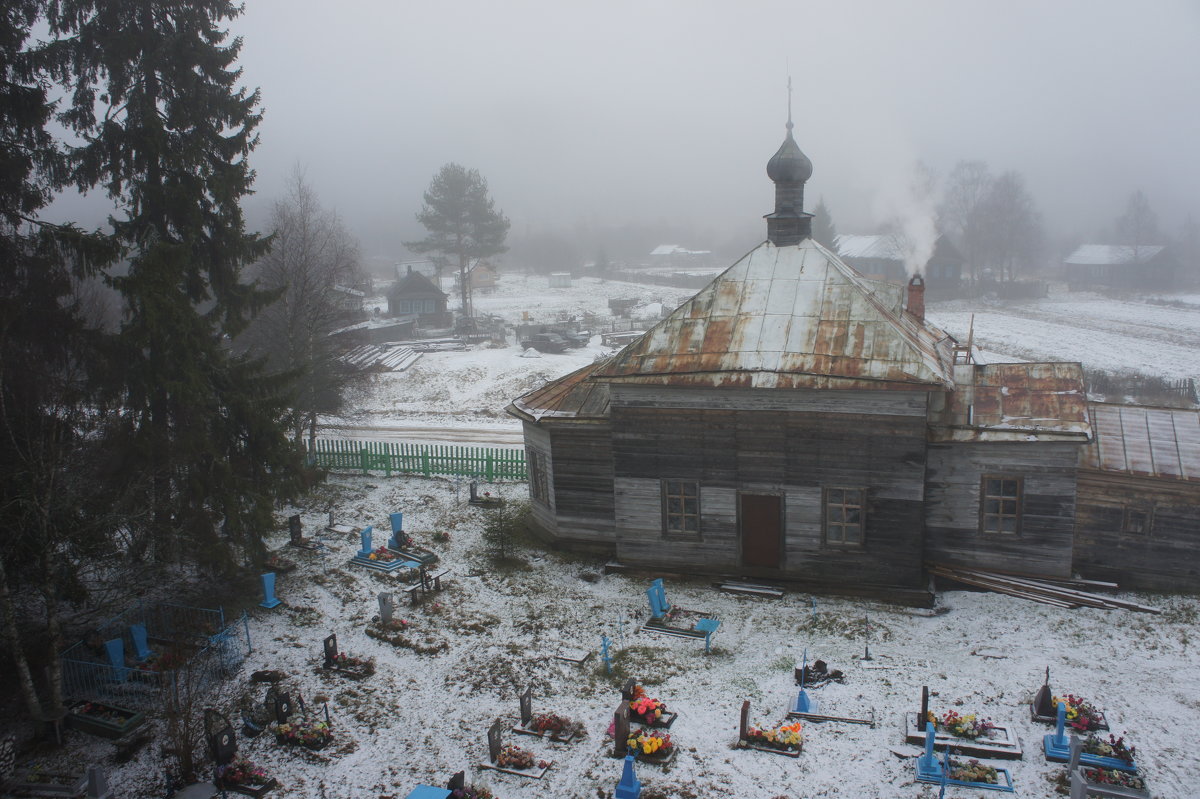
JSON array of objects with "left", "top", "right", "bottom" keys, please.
[{"left": 509, "top": 120, "right": 1200, "bottom": 603}]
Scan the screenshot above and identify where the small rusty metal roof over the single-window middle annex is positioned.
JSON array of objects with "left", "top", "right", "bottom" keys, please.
[{"left": 931, "top": 364, "right": 1091, "bottom": 441}]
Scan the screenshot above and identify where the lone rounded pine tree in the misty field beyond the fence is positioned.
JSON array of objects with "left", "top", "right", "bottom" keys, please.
[{"left": 404, "top": 163, "right": 509, "bottom": 320}]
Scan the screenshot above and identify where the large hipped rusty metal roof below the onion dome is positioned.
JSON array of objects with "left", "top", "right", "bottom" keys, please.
[{"left": 593, "top": 239, "right": 954, "bottom": 390}]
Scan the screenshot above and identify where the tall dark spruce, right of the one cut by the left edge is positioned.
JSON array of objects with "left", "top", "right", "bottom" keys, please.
[{"left": 43, "top": 0, "right": 309, "bottom": 573}]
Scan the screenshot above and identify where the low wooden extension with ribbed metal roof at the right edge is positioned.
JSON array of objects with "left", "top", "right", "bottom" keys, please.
[{"left": 1074, "top": 403, "right": 1200, "bottom": 591}]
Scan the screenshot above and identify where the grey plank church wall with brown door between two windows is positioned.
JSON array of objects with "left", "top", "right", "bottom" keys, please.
[{"left": 612, "top": 386, "right": 926, "bottom": 588}]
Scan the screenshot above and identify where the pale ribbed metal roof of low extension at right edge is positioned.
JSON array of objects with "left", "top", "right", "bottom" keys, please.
[{"left": 1081, "top": 402, "right": 1200, "bottom": 481}]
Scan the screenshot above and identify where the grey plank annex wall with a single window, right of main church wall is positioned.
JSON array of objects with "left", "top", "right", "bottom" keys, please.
[{"left": 925, "top": 441, "right": 1080, "bottom": 577}]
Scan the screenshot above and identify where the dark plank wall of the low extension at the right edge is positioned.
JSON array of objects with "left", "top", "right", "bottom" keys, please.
[{"left": 1075, "top": 469, "right": 1200, "bottom": 591}]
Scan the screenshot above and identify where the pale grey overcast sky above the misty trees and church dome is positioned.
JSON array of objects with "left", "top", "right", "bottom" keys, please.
[{"left": 164, "top": 0, "right": 1200, "bottom": 258}]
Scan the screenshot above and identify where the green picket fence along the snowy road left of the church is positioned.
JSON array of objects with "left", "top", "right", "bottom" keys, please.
[{"left": 308, "top": 438, "right": 529, "bottom": 482}]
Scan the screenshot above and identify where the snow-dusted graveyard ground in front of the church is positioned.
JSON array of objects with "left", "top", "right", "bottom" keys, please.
[{"left": 72, "top": 476, "right": 1200, "bottom": 799}]
